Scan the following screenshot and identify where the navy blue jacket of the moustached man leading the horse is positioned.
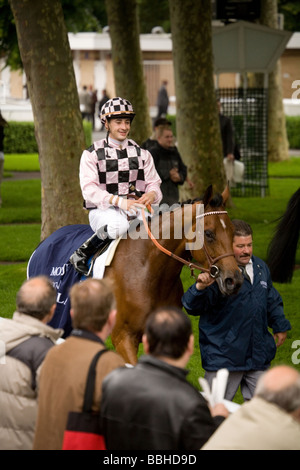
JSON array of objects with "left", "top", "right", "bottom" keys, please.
[{"left": 182, "top": 256, "right": 291, "bottom": 371}]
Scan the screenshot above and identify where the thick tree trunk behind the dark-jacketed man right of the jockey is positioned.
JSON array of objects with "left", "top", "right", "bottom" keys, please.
[{"left": 169, "top": 0, "right": 225, "bottom": 197}]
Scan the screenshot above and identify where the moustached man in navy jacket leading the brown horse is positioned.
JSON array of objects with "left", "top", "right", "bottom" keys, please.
[{"left": 182, "top": 220, "right": 291, "bottom": 400}]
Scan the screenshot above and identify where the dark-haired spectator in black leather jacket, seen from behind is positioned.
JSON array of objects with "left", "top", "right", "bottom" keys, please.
[{"left": 101, "top": 308, "right": 228, "bottom": 450}]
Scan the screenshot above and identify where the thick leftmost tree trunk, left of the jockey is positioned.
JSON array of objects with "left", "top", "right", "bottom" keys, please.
[{"left": 10, "top": 0, "right": 87, "bottom": 239}]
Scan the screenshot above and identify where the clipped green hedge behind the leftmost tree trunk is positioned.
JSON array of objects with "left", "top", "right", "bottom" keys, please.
[{"left": 4, "top": 121, "right": 92, "bottom": 153}]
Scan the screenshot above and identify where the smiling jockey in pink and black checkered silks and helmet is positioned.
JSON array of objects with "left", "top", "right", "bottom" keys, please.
[{"left": 70, "top": 97, "right": 162, "bottom": 274}]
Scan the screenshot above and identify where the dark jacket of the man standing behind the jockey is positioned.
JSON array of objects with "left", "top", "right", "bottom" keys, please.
[{"left": 149, "top": 142, "right": 187, "bottom": 206}]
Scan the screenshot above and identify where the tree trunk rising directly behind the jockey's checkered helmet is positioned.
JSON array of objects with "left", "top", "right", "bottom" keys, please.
[{"left": 105, "top": 0, "right": 152, "bottom": 144}]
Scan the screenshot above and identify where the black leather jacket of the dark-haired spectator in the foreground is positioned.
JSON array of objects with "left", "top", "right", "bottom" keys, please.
[{"left": 101, "top": 356, "right": 224, "bottom": 450}]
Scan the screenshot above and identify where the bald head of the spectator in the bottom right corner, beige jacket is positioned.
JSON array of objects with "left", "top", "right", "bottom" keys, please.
[{"left": 255, "top": 365, "right": 300, "bottom": 413}]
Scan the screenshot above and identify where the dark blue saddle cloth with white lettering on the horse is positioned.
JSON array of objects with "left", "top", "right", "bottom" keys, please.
[{"left": 27, "top": 224, "right": 94, "bottom": 337}]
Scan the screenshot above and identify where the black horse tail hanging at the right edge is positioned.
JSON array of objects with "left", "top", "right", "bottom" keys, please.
[{"left": 267, "top": 188, "right": 300, "bottom": 284}]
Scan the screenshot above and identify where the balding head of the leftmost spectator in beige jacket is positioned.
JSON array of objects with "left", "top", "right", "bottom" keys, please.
[{"left": 16, "top": 276, "right": 56, "bottom": 321}]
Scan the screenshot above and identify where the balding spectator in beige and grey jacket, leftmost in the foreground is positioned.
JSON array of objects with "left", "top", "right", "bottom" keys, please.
[{"left": 0, "top": 276, "right": 63, "bottom": 450}]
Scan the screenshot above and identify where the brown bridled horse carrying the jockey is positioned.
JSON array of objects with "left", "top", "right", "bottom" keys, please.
[{"left": 28, "top": 186, "right": 243, "bottom": 364}]
